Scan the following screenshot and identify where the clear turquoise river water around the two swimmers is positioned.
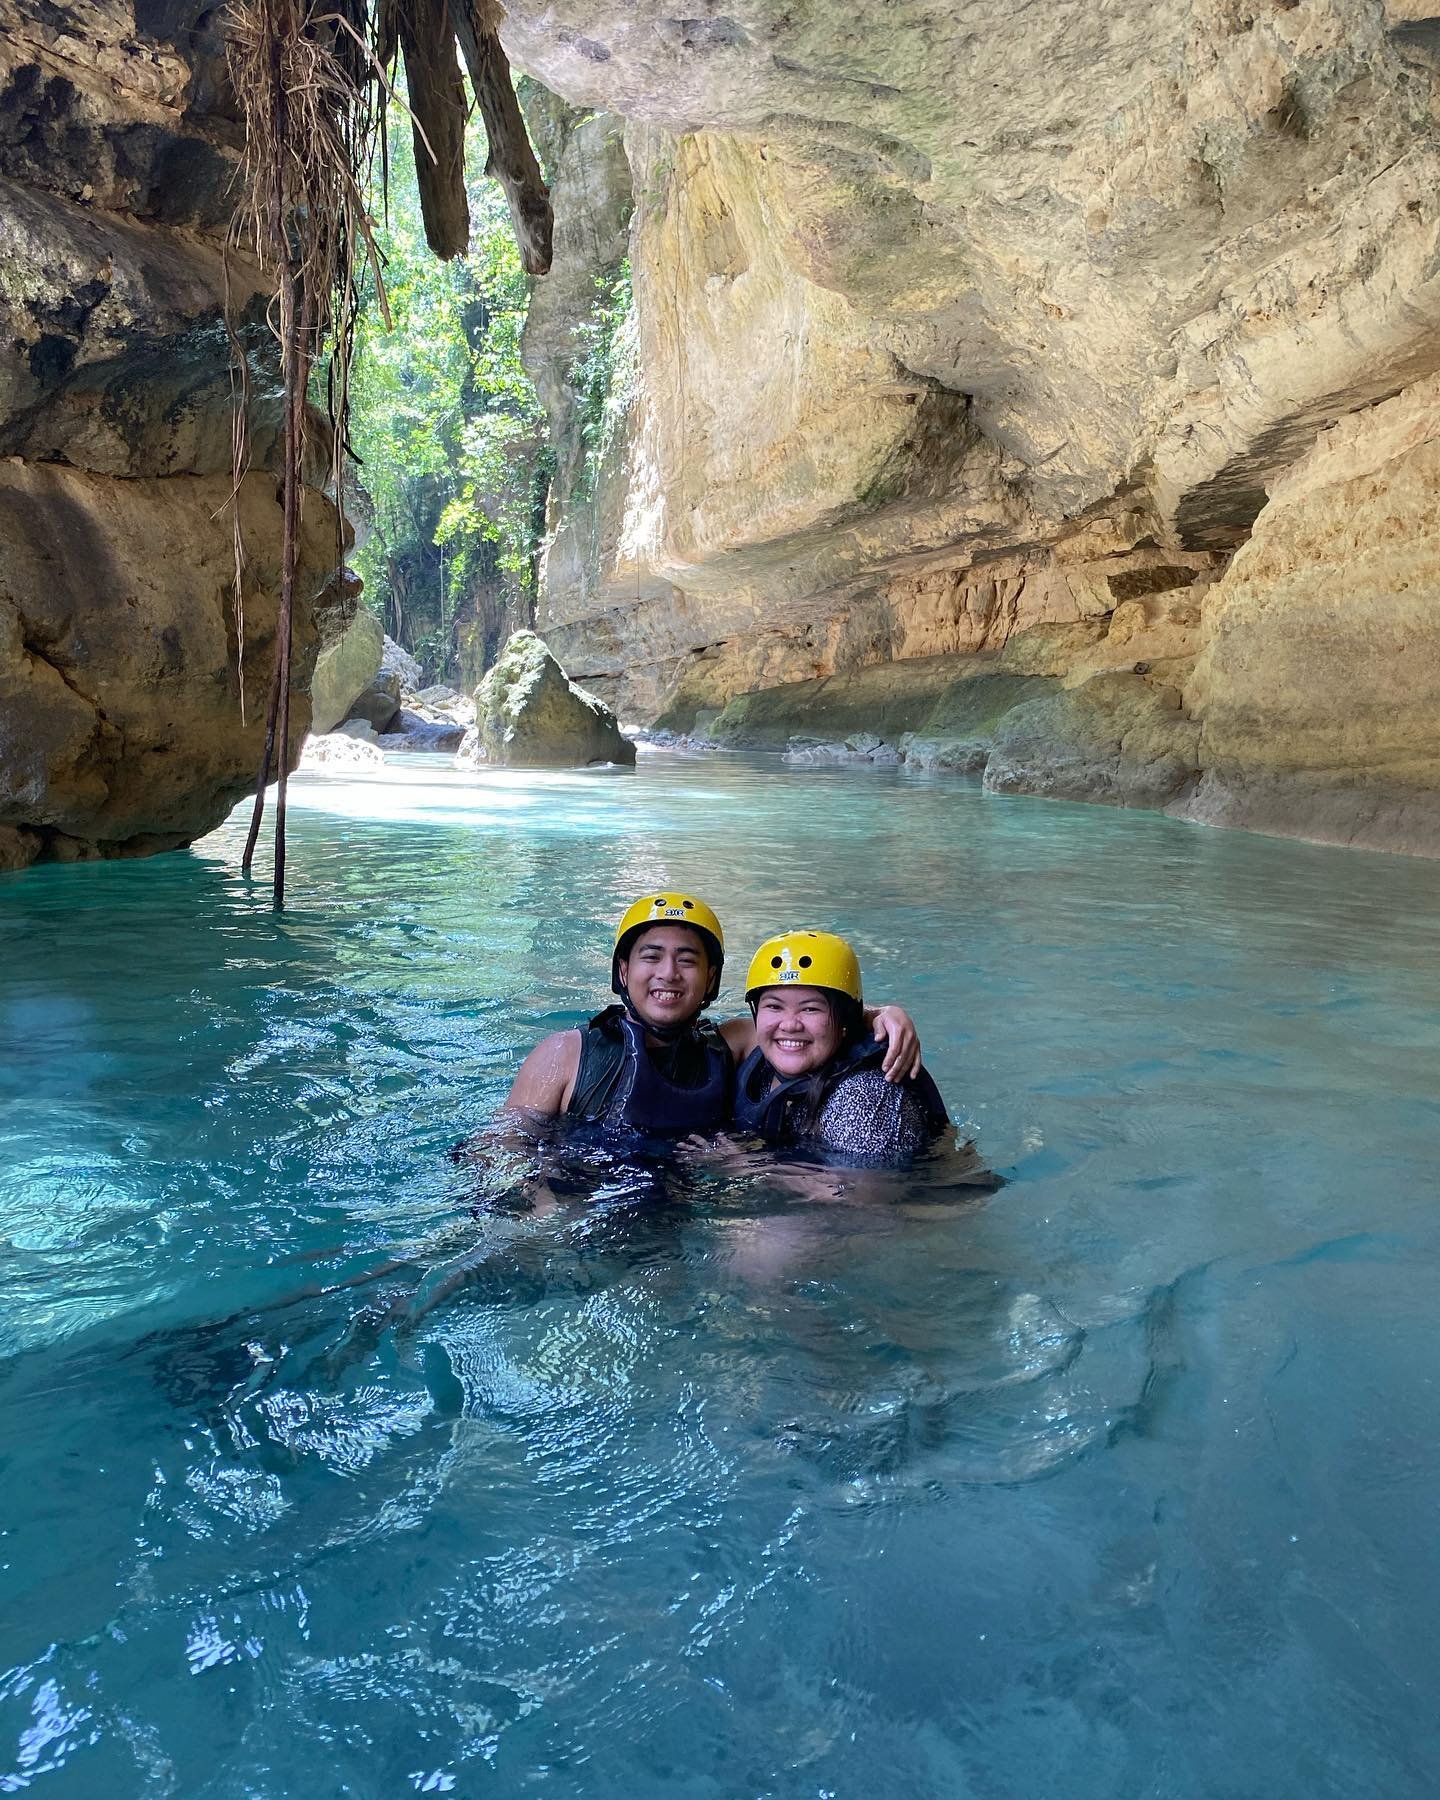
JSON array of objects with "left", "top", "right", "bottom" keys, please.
[{"left": 0, "top": 758, "right": 1440, "bottom": 1800}]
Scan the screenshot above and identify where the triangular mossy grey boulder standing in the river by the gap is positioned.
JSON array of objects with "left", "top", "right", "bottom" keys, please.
[{"left": 457, "top": 632, "right": 635, "bottom": 769}]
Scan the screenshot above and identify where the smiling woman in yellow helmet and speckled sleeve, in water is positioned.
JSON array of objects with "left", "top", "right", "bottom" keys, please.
[{"left": 734, "top": 931, "right": 949, "bottom": 1166}]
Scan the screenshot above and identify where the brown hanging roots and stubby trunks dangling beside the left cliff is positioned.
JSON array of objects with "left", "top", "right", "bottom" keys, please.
[{"left": 225, "top": 0, "right": 553, "bottom": 905}]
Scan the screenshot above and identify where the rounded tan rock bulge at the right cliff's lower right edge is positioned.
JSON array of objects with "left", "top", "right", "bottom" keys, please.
[{"left": 1184, "top": 380, "right": 1440, "bottom": 848}]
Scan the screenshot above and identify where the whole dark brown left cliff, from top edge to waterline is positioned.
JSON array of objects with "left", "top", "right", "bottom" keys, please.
[{"left": 0, "top": 0, "right": 355, "bottom": 868}]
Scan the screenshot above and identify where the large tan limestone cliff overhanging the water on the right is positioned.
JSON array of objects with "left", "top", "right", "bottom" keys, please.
[{"left": 502, "top": 0, "right": 1440, "bottom": 848}]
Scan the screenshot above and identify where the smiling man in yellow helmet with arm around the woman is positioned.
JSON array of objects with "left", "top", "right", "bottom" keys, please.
[{"left": 506, "top": 893, "right": 920, "bottom": 1138}]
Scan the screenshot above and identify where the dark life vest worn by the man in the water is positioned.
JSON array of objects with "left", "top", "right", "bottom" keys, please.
[{"left": 565, "top": 1006, "right": 734, "bottom": 1138}]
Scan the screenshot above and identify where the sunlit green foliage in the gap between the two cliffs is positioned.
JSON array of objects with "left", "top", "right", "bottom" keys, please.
[{"left": 340, "top": 94, "right": 551, "bottom": 675}]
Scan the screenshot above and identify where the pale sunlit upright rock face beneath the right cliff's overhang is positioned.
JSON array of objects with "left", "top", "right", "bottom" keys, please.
[{"left": 542, "top": 121, "right": 1026, "bottom": 706}]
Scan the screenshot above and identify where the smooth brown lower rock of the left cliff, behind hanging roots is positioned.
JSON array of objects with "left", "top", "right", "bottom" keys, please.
[{"left": 0, "top": 463, "right": 353, "bottom": 864}]
